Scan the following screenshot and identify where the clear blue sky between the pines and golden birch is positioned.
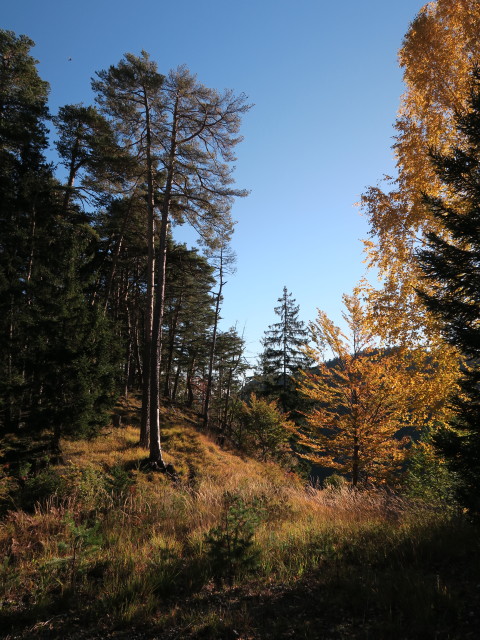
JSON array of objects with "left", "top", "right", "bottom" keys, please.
[{"left": 1, "top": 0, "right": 424, "bottom": 368}]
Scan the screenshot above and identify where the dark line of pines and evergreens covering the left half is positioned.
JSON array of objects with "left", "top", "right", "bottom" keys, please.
[{"left": 0, "top": 30, "right": 249, "bottom": 469}]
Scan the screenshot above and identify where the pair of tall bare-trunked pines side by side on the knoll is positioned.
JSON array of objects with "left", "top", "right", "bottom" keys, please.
[{"left": 93, "top": 58, "right": 249, "bottom": 469}]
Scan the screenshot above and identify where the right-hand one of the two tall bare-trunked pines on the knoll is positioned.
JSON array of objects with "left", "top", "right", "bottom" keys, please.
[{"left": 149, "top": 67, "right": 249, "bottom": 468}]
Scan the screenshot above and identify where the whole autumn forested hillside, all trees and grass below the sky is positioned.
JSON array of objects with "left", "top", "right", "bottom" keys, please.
[{"left": 0, "top": 0, "right": 480, "bottom": 640}]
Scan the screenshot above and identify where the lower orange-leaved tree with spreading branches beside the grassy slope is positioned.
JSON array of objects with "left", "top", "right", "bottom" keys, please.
[{"left": 299, "top": 296, "right": 456, "bottom": 486}]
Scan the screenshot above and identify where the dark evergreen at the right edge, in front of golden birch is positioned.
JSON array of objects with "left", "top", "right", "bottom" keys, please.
[{"left": 418, "top": 69, "right": 480, "bottom": 512}]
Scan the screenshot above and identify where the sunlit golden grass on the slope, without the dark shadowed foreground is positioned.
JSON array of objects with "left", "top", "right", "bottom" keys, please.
[{"left": 0, "top": 405, "right": 472, "bottom": 636}]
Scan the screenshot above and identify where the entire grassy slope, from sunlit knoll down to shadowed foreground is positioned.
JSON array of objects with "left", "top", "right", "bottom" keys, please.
[{"left": 0, "top": 406, "right": 480, "bottom": 640}]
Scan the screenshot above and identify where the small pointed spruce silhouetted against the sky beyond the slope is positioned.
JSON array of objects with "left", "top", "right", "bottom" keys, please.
[{"left": 259, "top": 287, "right": 308, "bottom": 409}]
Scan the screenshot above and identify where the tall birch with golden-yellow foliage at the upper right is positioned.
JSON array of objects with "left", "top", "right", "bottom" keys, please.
[{"left": 362, "top": 0, "right": 480, "bottom": 344}]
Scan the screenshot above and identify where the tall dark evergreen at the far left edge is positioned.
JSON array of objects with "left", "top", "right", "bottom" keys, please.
[{"left": 0, "top": 30, "right": 52, "bottom": 438}]
